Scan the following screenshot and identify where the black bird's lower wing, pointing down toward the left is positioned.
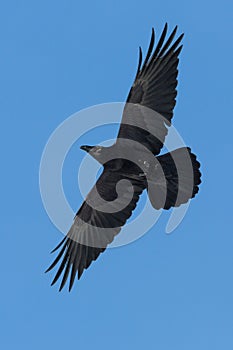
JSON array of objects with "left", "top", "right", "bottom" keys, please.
[{"left": 46, "top": 165, "right": 145, "bottom": 290}]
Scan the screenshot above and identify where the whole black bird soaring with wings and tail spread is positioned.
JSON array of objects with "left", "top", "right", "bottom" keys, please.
[{"left": 46, "top": 24, "right": 201, "bottom": 290}]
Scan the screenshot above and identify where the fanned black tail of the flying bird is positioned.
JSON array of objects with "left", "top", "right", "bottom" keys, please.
[{"left": 147, "top": 147, "right": 201, "bottom": 209}]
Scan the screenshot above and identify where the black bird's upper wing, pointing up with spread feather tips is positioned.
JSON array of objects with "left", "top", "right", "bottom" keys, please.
[{"left": 118, "top": 24, "right": 183, "bottom": 155}]
